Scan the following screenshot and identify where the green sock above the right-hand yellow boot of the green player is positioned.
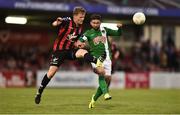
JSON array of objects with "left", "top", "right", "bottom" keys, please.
[{"left": 99, "top": 76, "right": 108, "bottom": 94}]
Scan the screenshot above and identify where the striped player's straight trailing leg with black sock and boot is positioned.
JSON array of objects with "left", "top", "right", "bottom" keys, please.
[{"left": 35, "top": 66, "right": 58, "bottom": 104}]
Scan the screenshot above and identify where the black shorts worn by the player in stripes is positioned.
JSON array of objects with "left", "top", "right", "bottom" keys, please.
[{"left": 50, "top": 49, "right": 78, "bottom": 67}]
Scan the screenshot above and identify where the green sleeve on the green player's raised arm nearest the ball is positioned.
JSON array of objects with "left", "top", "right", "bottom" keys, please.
[{"left": 105, "top": 28, "right": 122, "bottom": 36}]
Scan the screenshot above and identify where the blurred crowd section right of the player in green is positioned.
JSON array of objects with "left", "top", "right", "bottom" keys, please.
[{"left": 114, "top": 40, "right": 180, "bottom": 72}]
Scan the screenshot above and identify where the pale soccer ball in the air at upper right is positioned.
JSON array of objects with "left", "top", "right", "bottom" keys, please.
[{"left": 133, "top": 12, "right": 146, "bottom": 25}]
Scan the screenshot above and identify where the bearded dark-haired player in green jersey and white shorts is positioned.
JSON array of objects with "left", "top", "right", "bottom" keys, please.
[{"left": 78, "top": 14, "right": 122, "bottom": 108}]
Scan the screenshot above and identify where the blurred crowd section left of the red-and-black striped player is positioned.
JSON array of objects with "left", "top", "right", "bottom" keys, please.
[{"left": 0, "top": 44, "right": 49, "bottom": 71}]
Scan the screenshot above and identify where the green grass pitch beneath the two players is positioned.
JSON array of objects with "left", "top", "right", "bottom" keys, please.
[{"left": 0, "top": 88, "right": 180, "bottom": 114}]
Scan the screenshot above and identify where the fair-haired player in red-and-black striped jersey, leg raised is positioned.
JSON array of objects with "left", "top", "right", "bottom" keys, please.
[{"left": 35, "top": 7, "right": 105, "bottom": 104}]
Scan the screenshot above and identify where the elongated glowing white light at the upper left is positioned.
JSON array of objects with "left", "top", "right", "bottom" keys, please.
[{"left": 5, "top": 16, "right": 27, "bottom": 24}]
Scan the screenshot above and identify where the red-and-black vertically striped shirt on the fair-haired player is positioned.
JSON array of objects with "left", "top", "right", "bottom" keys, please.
[{"left": 53, "top": 17, "right": 82, "bottom": 51}]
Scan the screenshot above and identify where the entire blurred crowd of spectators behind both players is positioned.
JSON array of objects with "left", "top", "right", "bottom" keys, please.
[{"left": 0, "top": 40, "right": 180, "bottom": 72}]
